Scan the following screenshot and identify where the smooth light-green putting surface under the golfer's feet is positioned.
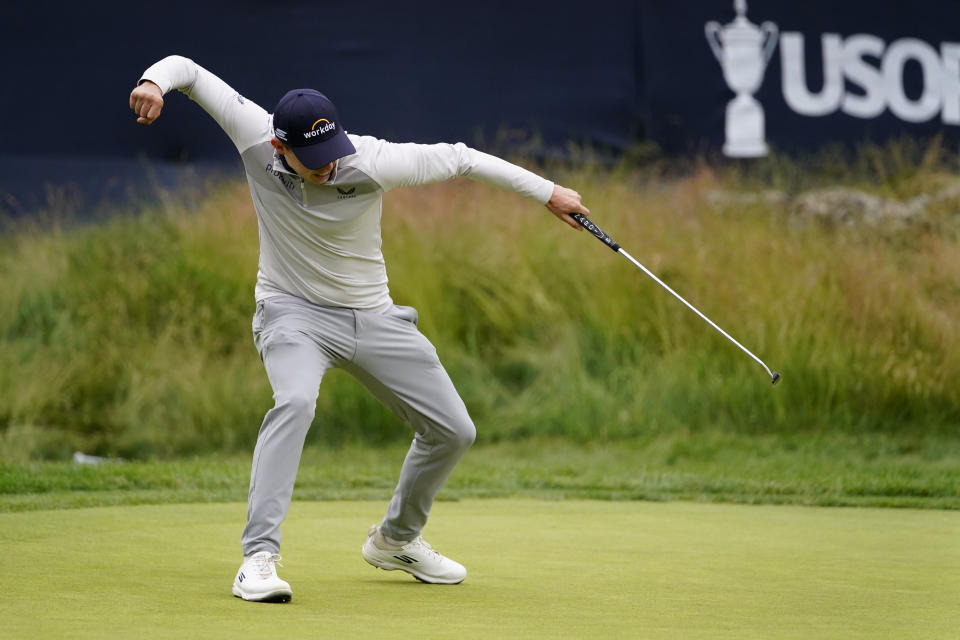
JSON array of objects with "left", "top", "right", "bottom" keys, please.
[{"left": 0, "top": 499, "right": 960, "bottom": 640}]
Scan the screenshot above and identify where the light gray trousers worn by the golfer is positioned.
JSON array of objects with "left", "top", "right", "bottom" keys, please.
[{"left": 241, "top": 296, "right": 476, "bottom": 556}]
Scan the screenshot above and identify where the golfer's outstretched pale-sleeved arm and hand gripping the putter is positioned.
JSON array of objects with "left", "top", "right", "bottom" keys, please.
[{"left": 373, "top": 141, "right": 590, "bottom": 230}]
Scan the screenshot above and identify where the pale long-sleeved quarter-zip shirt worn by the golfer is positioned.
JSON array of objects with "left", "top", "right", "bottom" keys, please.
[{"left": 141, "top": 56, "right": 553, "bottom": 312}]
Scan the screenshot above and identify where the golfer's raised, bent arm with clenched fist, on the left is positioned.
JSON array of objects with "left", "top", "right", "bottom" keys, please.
[{"left": 130, "top": 56, "right": 272, "bottom": 152}]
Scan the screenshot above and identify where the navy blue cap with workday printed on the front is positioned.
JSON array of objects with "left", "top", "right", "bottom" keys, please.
[{"left": 273, "top": 89, "right": 357, "bottom": 169}]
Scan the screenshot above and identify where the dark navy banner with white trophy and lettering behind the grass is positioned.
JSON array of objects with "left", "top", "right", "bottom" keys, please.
[{"left": 0, "top": 0, "right": 960, "bottom": 214}]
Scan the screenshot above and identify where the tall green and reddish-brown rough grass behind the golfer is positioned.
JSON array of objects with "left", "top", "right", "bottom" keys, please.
[{"left": 0, "top": 148, "right": 960, "bottom": 460}]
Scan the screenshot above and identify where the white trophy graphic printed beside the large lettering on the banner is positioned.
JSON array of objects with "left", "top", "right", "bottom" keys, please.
[{"left": 704, "top": 0, "right": 779, "bottom": 158}]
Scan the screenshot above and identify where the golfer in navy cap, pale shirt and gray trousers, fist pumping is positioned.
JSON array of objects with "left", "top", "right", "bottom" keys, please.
[{"left": 130, "top": 56, "right": 589, "bottom": 602}]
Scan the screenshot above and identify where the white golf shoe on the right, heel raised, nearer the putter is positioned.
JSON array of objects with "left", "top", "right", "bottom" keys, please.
[{"left": 362, "top": 525, "right": 467, "bottom": 584}]
